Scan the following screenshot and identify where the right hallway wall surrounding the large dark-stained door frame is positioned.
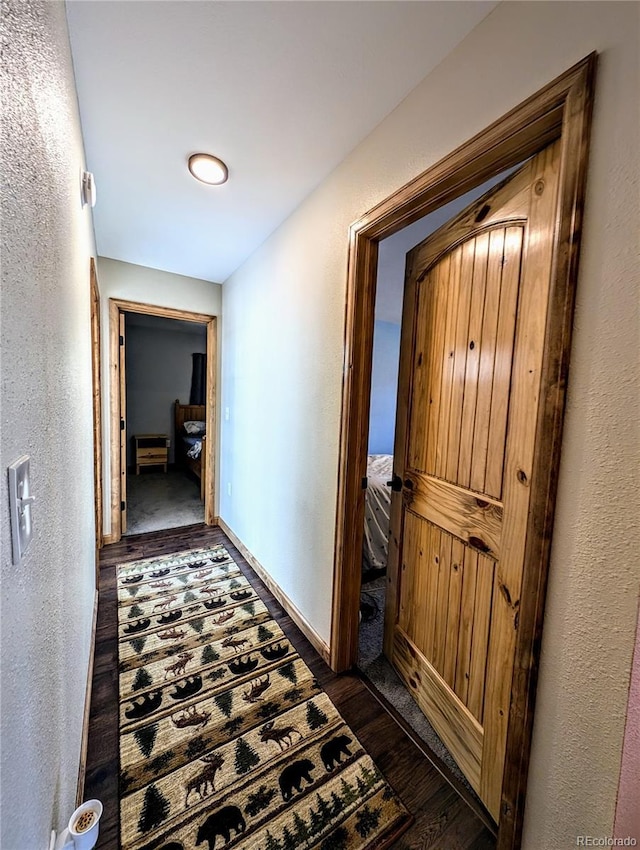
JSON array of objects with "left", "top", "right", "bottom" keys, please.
[{"left": 220, "top": 2, "right": 640, "bottom": 850}]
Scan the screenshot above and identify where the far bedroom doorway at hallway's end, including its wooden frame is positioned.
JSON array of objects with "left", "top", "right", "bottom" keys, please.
[{"left": 109, "top": 299, "right": 216, "bottom": 542}]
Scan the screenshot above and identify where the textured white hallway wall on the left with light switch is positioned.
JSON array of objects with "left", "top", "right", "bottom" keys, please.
[{"left": 0, "top": 0, "right": 95, "bottom": 850}]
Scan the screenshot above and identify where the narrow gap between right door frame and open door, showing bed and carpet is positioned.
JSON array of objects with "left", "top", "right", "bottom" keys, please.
[{"left": 357, "top": 165, "right": 520, "bottom": 828}]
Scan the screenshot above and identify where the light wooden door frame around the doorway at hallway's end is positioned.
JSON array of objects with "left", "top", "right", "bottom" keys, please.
[{"left": 109, "top": 298, "right": 218, "bottom": 543}]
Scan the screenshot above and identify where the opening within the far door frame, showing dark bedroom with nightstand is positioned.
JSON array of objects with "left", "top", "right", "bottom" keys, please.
[{"left": 121, "top": 312, "right": 207, "bottom": 535}]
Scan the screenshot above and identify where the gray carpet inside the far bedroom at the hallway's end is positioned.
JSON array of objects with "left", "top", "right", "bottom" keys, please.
[{"left": 126, "top": 469, "right": 204, "bottom": 534}]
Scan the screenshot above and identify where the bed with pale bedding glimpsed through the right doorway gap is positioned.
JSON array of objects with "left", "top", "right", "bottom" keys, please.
[{"left": 362, "top": 455, "right": 393, "bottom": 571}]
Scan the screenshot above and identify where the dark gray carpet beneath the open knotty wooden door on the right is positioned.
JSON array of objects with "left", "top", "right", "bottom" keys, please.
[{"left": 358, "top": 576, "right": 473, "bottom": 793}]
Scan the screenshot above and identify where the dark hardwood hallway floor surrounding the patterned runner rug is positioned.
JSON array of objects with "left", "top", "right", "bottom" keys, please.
[{"left": 85, "top": 525, "right": 495, "bottom": 850}]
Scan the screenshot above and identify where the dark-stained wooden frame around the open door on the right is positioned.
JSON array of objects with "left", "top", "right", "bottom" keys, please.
[{"left": 330, "top": 52, "right": 597, "bottom": 850}]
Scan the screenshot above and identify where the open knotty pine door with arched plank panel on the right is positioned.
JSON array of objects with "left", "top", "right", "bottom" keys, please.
[{"left": 385, "top": 142, "right": 560, "bottom": 821}]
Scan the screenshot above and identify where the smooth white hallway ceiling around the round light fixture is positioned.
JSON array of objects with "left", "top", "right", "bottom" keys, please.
[{"left": 67, "top": 0, "right": 496, "bottom": 283}]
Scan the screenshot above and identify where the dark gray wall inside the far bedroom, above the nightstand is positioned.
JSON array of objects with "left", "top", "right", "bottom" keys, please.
[{"left": 126, "top": 313, "right": 207, "bottom": 467}]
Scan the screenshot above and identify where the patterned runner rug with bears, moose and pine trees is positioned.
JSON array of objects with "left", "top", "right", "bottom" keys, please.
[{"left": 118, "top": 546, "right": 412, "bottom": 850}]
